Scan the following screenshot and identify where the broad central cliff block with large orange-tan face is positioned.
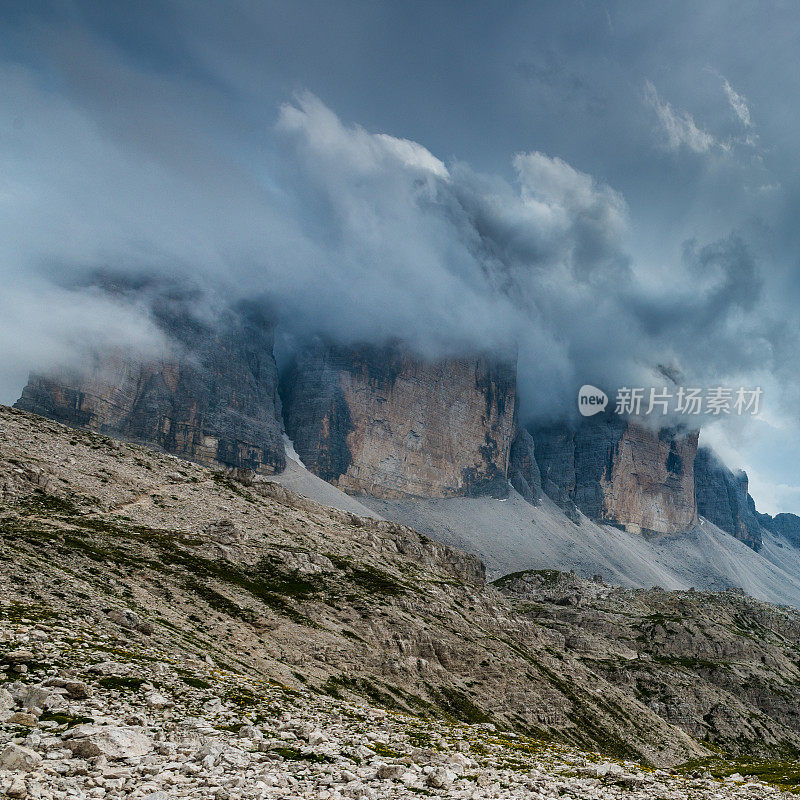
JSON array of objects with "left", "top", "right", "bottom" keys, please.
[{"left": 284, "top": 345, "right": 516, "bottom": 499}]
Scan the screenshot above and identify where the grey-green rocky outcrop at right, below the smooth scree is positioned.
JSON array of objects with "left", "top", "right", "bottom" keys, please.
[{"left": 497, "top": 571, "right": 800, "bottom": 760}]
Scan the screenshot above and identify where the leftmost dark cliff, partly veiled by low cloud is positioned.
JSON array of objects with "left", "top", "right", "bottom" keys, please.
[{"left": 16, "top": 302, "right": 285, "bottom": 473}]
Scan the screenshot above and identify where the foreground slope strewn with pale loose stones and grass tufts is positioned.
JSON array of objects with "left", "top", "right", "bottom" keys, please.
[{"left": 0, "top": 616, "right": 800, "bottom": 800}]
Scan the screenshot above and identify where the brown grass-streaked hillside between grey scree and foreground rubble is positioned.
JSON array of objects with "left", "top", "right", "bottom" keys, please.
[{"left": 0, "top": 409, "right": 800, "bottom": 788}]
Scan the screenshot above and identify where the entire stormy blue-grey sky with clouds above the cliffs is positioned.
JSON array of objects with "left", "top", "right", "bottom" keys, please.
[{"left": 0, "top": 0, "right": 800, "bottom": 513}]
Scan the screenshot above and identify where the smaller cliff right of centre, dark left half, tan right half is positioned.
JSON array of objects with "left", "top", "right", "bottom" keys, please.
[{"left": 533, "top": 414, "right": 697, "bottom": 533}]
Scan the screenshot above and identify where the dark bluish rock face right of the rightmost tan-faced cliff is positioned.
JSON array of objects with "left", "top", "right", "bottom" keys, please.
[{"left": 694, "top": 447, "right": 764, "bottom": 550}]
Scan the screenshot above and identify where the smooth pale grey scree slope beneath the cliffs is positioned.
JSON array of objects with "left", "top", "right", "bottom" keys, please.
[{"left": 359, "top": 491, "right": 800, "bottom": 608}]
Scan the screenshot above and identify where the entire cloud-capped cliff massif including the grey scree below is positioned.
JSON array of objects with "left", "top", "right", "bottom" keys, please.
[{"left": 17, "top": 304, "right": 800, "bottom": 606}]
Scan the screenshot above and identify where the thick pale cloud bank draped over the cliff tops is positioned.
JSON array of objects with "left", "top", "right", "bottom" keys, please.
[{"left": 0, "top": 75, "right": 772, "bottom": 418}]
